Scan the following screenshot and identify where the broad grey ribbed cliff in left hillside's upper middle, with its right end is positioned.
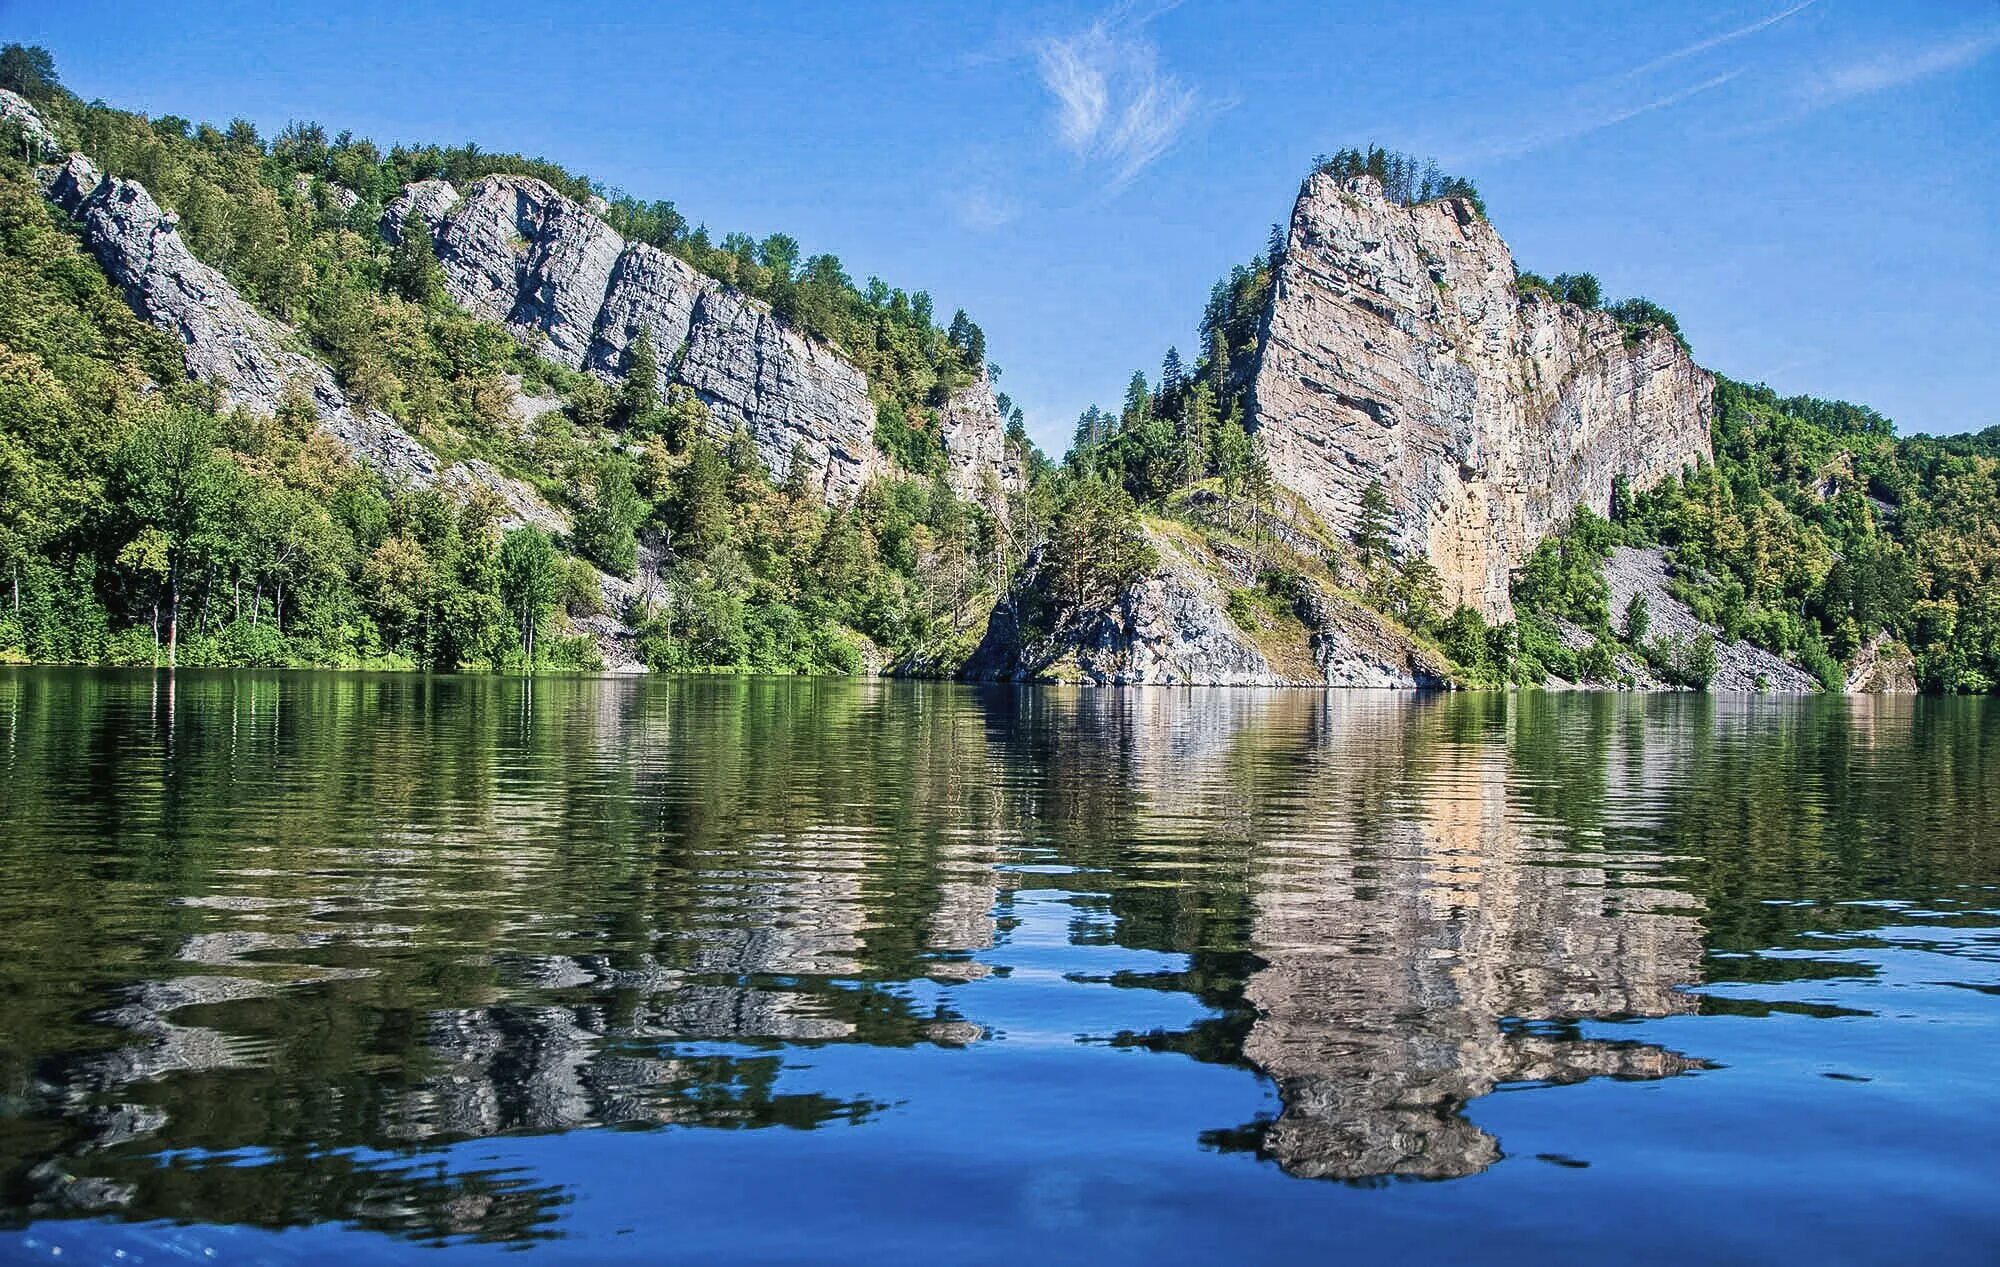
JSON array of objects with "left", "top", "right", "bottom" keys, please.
[{"left": 382, "top": 176, "right": 1020, "bottom": 500}]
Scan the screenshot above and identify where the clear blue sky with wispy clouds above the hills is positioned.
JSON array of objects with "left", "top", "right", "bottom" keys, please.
[{"left": 0, "top": 0, "right": 2000, "bottom": 452}]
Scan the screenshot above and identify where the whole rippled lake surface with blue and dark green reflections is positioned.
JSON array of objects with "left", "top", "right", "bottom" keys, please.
[{"left": 0, "top": 669, "right": 2000, "bottom": 1263}]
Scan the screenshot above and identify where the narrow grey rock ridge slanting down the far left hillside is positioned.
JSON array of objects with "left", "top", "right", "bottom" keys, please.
[{"left": 44, "top": 154, "right": 568, "bottom": 532}]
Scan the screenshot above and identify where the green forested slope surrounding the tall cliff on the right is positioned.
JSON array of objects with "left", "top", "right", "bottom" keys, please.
[{"left": 1052, "top": 148, "right": 2000, "bottom": 691}]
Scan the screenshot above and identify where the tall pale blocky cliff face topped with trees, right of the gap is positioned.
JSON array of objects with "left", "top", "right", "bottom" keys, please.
[{"left": 1250, "top": 174, "right": 1714, "bottom": 618}]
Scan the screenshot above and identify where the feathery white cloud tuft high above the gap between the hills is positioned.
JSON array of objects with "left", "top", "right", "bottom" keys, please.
[{"left": 1034, "top": 16, "right": 1202, "bottom": 190}]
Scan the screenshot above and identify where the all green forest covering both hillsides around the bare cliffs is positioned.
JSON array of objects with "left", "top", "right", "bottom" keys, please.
[{"left": 0, "top": 46, "right": 2000, "bottom": 691}]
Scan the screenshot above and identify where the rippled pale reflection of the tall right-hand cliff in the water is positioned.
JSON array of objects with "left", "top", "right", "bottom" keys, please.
[{"left": 968, "top": 693, "right": 1702, "bottom": 1179}]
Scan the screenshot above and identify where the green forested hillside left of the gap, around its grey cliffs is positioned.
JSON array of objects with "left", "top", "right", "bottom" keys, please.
[{"left": 0, "top": 46, "right": 1026, "bottom": 671}]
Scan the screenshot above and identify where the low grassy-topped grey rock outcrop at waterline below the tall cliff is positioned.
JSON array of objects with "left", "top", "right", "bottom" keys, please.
[{"left": 964, "top": 530, "right": 1450, "bottom": 689}]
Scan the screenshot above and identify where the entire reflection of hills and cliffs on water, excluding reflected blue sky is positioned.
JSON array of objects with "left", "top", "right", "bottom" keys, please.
[{"left": 0, "top": 671, "right": 1992, "bottom": 1241}]
